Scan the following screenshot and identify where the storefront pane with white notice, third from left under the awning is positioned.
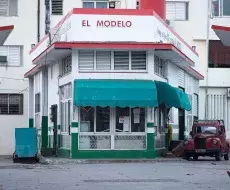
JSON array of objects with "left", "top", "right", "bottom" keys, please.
[{"left": 116, "top": 107, "right": 130, "bottom": 132}]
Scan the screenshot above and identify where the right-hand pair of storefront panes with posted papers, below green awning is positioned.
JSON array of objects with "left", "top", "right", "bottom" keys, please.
[{"left": 116, "top": 107, "right": 145, "bottom": 132}]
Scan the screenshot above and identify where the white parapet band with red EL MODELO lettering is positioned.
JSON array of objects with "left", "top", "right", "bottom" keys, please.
[{"left": 32, "top": 14, "right": 198, "bottom": 66}]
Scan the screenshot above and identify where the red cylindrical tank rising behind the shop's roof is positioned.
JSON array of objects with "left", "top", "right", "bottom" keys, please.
[{"left": 139, "top": 0, "right": 166, "bottom": 20}]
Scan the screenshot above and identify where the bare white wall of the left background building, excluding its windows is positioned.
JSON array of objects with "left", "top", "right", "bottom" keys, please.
[{"left": 0, "top": 0, "right": 44, "bottom": 155}]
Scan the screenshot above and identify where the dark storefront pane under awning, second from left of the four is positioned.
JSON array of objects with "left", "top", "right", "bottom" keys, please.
[{"left": 96, "top": 107, "right": 110, "bottom": 132}]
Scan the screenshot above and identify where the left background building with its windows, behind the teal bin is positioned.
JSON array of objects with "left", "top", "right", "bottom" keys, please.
[{"left": 0, "top": 0, "right": 44, "bottom": 155}]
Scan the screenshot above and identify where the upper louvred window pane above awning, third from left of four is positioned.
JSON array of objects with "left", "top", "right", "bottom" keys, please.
[{"left": 114, "top": 51, "right": 129, "bottom": 70}]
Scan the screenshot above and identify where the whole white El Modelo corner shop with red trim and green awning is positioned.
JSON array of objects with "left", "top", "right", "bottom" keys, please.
[{"left": 25, "top": 8, "right": 203, "bottom": 158}]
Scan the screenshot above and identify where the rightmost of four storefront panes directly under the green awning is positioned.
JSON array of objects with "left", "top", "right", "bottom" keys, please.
[{"left": 131, "top": 108, "right": 145, "bottom": 132}]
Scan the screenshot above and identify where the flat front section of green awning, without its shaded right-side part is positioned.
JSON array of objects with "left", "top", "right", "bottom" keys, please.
[{"left": 74, "top": 80, "right": 158, "bottom": 107}]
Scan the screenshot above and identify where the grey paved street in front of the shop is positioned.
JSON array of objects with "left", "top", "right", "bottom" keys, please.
[{"left": 0, "top": 160, "right": 230, "bottom": 190}]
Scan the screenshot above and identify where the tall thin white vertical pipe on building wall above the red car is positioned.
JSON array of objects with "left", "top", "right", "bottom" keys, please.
[{"left": 205, "top": 0, "right": 211, "bottom": 119}]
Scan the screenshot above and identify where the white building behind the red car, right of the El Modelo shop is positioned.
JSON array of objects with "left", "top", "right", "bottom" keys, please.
[{"left": 166, "top": 0, "right": 230, "bottom": 138}]
